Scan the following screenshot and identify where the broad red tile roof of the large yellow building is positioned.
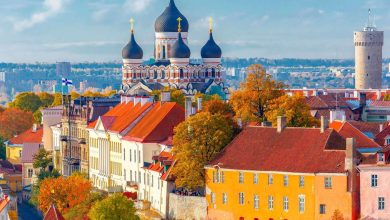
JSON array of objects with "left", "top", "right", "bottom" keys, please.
[{"left": 209, "top": 126, "right": 345, "bottom": 173}]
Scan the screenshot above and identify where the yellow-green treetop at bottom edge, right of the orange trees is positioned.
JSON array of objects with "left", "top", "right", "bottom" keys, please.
[{"left": 88, "top": 193, "right": 140, "bottom": 220}]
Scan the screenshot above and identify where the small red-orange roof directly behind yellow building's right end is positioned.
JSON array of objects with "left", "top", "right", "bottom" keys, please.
[{"left": 329, "top": 121, "right": 380, "bottom": 148}]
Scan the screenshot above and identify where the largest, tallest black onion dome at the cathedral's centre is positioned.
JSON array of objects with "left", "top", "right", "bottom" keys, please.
[{"left": 154, "top": 0, "right": 189, "bottom": 32}]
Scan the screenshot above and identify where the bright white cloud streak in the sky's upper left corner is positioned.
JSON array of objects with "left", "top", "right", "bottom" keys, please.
[{"left": 13, "top": 0, "right": 66, "bottom": 31}]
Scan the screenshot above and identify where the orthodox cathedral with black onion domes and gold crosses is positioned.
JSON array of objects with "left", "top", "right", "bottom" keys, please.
[{"left": 121, "top": 0, "right": 228, "bottom": 98}]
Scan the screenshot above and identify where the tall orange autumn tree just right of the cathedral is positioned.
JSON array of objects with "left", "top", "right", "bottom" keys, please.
[{"left": 230, "top": 64, "right": 285, "bottom": 122}]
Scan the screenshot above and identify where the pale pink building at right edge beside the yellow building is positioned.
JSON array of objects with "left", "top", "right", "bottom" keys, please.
[{"left": 359, "top": 145, "right": 390, "bottom": 220}]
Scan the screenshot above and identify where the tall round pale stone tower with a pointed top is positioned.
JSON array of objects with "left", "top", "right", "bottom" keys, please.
[{"left": 354, "top": 10, "right": 383, "bottom": 89}]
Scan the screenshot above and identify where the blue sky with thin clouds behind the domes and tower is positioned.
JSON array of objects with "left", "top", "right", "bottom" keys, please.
[{"left": 0, "top": 0, "right": 390, "bottom": 62}]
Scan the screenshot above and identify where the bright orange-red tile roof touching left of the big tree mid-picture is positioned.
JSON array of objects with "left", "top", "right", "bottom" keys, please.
[{"left": 124, "top": 102, "right": 185, "bottom": 142}]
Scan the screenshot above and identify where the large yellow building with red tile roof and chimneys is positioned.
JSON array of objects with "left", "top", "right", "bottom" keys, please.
[{"left": 205, "top": 118, "right": 358, "bottom": 220}]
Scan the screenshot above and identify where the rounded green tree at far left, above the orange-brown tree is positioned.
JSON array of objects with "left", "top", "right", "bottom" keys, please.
[{"left": 9, "top": 92, "right": 42, "bottom": 112}]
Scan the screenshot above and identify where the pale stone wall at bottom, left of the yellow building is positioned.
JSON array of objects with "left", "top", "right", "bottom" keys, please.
[{"left": 168, "top": 193, "right": 207, "bottom": 220}]
